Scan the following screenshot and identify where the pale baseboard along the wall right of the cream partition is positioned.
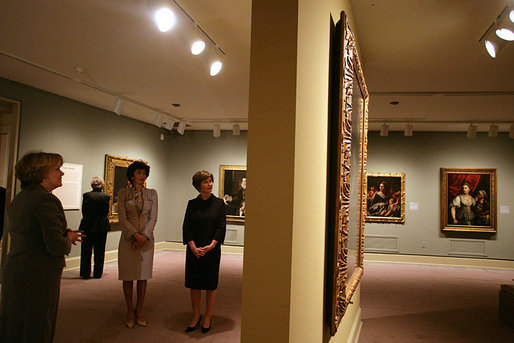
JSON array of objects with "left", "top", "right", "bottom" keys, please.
[{"left": 364, "top": 253, "right": 514, "bottom": 269}]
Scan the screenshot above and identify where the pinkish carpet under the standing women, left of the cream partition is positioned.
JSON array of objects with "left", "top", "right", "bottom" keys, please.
[{"left": 55, "top": 251, "right": 243, "bottom": 343}]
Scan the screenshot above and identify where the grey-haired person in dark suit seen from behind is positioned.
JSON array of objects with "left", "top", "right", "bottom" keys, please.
[{"left": 79, "top": 176, "right": 111, "bottom": 279}]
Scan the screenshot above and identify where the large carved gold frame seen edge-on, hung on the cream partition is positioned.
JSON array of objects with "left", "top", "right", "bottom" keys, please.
[{"left": 326, "top": 12, "right": 369, "bottom": 335}]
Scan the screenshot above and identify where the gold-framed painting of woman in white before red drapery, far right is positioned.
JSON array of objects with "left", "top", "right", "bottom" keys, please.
[{"left": 441, "top": 168, "right": 497, "bottom": 233}]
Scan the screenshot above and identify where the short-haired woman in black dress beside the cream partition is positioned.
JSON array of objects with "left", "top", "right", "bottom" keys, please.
[{"left": 182, "top": 170, "right": 226, "bottom": 333}]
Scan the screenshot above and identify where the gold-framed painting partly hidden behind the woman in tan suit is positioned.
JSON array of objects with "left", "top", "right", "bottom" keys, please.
[{"left": 104, "top": 154, "right": 146, "bottom": 223}]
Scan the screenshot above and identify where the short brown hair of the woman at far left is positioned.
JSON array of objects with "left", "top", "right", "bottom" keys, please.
[{"left": 15, "top": 151, "right": 63, "bottom": 189}]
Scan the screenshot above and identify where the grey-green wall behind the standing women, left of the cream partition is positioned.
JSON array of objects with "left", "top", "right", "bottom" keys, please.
[{"left": 0, "top": 78, "right": 246, "bottom": 257}]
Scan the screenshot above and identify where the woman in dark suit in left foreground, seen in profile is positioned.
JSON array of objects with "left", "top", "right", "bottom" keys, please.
[{"left": 0, "top": 152, "right": 83, "bottom": 343}]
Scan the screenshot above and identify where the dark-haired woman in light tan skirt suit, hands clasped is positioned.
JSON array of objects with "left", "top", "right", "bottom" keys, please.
[{"left": 118, "top": 161, "right": 157, "bottom": 329}]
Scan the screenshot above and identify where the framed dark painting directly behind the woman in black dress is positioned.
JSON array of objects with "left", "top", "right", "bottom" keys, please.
[{"left": 219, "top": 165, "right": 246, "bottom": 223}]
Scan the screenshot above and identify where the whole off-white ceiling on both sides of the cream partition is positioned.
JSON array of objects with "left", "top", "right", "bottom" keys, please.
[{"left": 0, "top": 0, "right": 514, "bottom": 131}]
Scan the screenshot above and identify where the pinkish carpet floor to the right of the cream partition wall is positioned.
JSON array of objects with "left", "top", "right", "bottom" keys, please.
[{"left": 359, "top": 263, "right": 514, "bottom": 343}]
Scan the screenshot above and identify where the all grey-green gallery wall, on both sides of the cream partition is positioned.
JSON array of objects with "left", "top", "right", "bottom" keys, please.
[{"left": 0, "top": 79, "right": 514, "bottom": 260}]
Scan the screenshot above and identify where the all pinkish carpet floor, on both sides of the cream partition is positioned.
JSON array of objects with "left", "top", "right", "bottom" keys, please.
[{"left": 55, "top": 251, "right": 514, "bottom": 343}]
